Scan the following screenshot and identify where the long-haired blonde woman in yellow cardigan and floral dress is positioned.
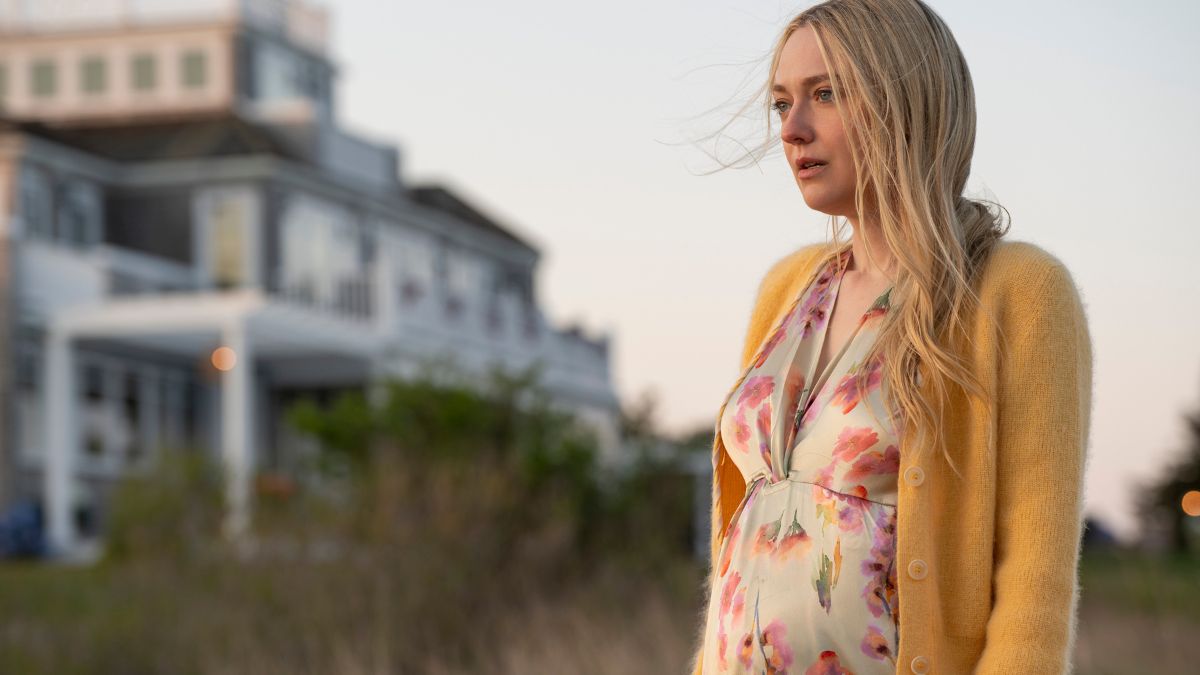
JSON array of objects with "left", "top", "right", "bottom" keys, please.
[{"left": 694, "top": 0, "right": 1092, "bottom": 675}]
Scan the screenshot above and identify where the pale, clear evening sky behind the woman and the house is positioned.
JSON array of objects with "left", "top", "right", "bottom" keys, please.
[{"left": 320, "top": 0, "right": 1200, "bottom": 538}]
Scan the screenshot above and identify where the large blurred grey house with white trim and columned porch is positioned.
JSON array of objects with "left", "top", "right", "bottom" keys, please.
[{"left": 0, "top": 0, "right": 620, "bottom": 551}]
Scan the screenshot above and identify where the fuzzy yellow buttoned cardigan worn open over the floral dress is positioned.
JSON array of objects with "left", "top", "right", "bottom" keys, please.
[{"left": 692, "top": 240, "right": 1092, "bottom": 675}]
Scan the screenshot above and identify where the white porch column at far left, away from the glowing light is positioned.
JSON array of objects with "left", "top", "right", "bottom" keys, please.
[{"left": 42, "top": 323, "right": 79, "bottom": 555}]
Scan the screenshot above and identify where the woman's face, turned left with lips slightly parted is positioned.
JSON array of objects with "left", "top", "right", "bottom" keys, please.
[{"left": 772, "top": 25, "right": 857, "bottom": 217}]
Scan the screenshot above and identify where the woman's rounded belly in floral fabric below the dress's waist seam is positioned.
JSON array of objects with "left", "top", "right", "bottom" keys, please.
[{"left": 706, "top": 479, "right": 899, "bottom": 675}]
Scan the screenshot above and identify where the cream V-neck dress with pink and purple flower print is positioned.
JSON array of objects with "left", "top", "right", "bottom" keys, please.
[{"left": 702, "top": 247, "right": 900, "bottom": 675}]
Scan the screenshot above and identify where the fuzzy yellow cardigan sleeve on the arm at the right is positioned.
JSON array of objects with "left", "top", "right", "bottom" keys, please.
[{"left": 974, "top": 261, "right": 1092, "bottom": 675}]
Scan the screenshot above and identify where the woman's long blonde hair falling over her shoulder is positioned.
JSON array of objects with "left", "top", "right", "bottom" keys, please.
[{"left": 764, "top": 0, "right": 1008, "bottom": 476}]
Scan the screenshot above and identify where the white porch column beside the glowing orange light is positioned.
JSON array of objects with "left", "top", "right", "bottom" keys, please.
[{"left": 221, "top": 319, "right": 256, "bottom": 537}]
